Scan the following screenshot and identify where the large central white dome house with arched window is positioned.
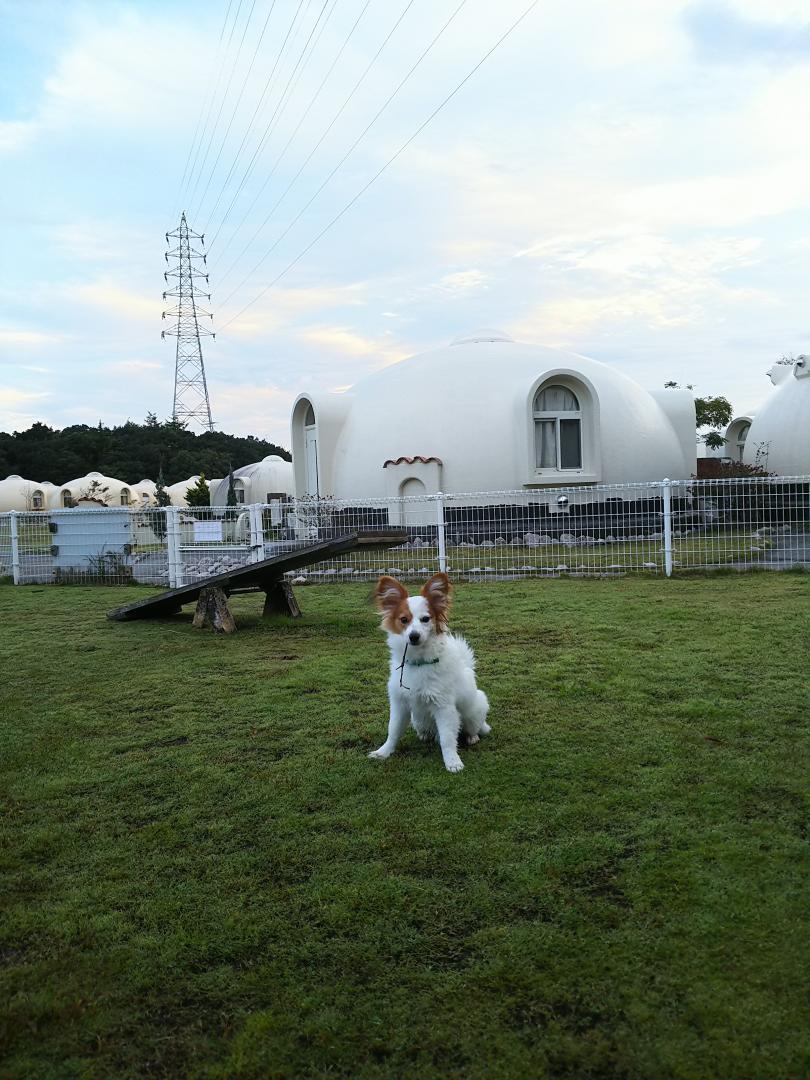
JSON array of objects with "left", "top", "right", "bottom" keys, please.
[{"left": 292, "top": 330, "right": 696, "bottom": 500}]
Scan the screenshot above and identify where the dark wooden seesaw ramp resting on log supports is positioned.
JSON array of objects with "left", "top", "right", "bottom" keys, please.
[{"left": 107, "top": 529, "right": 407, "bottom": 634}]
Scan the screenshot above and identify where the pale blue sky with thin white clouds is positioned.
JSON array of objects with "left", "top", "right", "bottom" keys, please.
[{"left": 0, "top": 0, "right": 810, "bottom": 446}]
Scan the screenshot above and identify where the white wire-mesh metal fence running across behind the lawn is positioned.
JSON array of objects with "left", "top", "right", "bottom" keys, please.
[{"left": 0, "top": 476, "right": 810, "bottom": 586}]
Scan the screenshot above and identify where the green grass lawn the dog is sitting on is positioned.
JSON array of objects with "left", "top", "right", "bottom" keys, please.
[{"left": 0, "top": 573, "right": 810, "bottom": 1080}]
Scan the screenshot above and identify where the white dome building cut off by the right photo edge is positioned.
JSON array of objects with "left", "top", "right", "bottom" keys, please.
[{"left": 743, "top": 356, "right": 810, "bottom": 476}]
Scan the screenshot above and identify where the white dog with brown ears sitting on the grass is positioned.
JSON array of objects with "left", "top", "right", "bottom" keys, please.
[{"left": 368, "top": 573, "right": 490, "bottom": 772}]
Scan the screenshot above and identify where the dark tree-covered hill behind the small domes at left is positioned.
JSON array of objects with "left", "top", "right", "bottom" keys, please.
[{"left": 0, "top": 415, "right": 292, "bottom": 484}]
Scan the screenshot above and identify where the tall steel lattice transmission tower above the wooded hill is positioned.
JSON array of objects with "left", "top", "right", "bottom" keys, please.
[{"left": 161, "top": 212, "right": 216, "bottom": 431}]
